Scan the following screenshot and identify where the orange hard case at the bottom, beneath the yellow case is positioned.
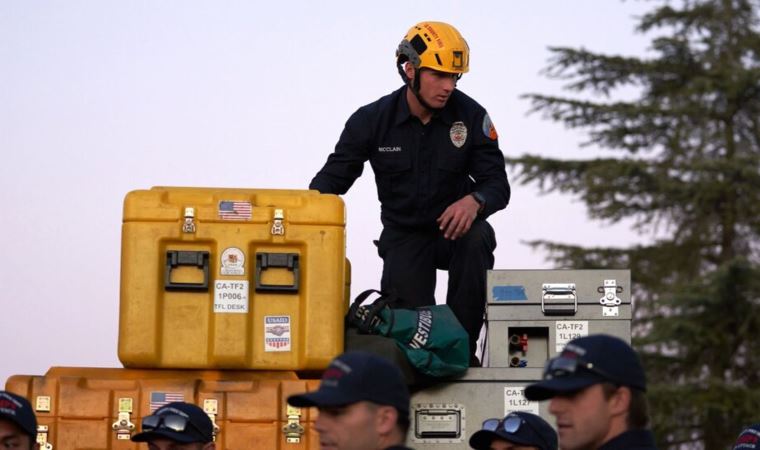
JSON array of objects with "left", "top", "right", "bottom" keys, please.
[{"left": 6, "top": 367, "right": 319, "bottom": 450}]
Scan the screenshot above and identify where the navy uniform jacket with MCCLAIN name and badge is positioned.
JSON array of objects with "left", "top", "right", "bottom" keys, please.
[{"left": 309, "top": 86, "right": 510, "bottom": 229}]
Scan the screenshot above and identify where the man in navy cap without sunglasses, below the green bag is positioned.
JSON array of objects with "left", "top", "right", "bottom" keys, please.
[{"left": 288, "top": 352, "right": 416, "bottom": 450}]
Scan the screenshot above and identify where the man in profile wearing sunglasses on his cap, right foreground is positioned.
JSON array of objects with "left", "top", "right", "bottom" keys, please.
[{"left": 525, "top": 334, "right": 656, "bottom": 450}]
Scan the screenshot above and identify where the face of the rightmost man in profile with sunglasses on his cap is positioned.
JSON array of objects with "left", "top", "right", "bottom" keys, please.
[{"left": 549, "top": 384, "right": 612, "bottom": 450}]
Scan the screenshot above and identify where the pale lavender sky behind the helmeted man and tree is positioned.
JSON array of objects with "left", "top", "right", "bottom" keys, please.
[{"left": 0, "top": 0, "right": 654, "bottom": 386}]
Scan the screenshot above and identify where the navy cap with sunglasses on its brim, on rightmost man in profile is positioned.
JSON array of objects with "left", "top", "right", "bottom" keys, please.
[{"left": 525, "top": 334, "right": 646, "bottom": 400}]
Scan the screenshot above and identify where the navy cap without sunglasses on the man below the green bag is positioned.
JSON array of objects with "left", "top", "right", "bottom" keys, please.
[{"left": 288, "top": 351, "right": 409, "bottom": 418}]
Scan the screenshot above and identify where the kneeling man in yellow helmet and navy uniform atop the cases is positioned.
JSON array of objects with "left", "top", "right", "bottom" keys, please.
[{"left": 309, "top": 22, "right": 510, "bottom": 365}]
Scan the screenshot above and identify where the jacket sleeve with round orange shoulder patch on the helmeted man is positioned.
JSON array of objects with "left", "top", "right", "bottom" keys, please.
[{"left": 469, "top": 111, "right": 511, "bottom": 218}]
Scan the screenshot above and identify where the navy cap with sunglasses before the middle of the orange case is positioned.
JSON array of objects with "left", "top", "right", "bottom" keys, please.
[{"left": 132, "top": 402, "right": 214, "bottom": 444}]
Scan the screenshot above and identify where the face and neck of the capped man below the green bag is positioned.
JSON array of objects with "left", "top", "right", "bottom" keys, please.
[{"left": 314, "top": 402, "right": 386, "bottom": 450}]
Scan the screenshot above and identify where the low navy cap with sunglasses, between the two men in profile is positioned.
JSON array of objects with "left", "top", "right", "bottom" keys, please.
[{"left": 470, "top": 411, "right": 557, "bottom": 450}]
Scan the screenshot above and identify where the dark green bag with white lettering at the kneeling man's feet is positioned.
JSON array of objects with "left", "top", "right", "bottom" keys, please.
[{"left": 347, "top": 289, "right": 470, "bottom": 377}]
